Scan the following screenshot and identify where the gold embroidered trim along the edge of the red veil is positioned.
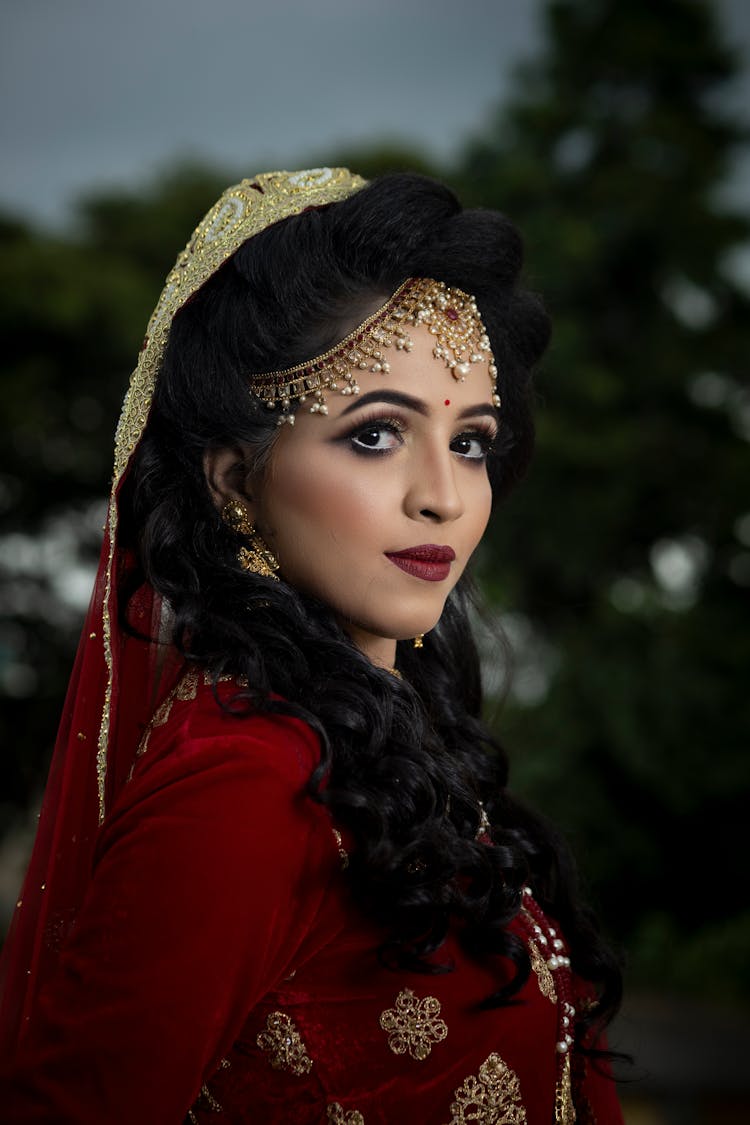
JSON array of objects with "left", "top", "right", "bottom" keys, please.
[{"left": 97, "top": 168, "right": 365, "bottom": 821}]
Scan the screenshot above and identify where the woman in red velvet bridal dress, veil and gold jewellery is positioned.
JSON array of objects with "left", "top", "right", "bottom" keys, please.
[{"left": 3, "top": 169, "right": 621, "bottom": 1125}]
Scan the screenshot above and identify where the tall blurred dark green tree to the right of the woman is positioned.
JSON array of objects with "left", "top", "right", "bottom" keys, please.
[{"left": 459, "top": 0, "right": 750, "bottom": 996}]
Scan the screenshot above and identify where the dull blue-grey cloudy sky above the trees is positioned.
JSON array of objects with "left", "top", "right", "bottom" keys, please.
[{"left": 0, "top": 0, "right": 750, "bottom": 223}]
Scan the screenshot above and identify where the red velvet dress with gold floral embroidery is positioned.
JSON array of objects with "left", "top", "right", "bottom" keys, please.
[{"left": 0, "top": 676, "right": 622, "bottom": 1125}]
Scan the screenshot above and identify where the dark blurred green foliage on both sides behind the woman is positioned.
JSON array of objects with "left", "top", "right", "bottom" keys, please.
[{"left": 0, "top": 0, "right": 750, "bottom": 1107}]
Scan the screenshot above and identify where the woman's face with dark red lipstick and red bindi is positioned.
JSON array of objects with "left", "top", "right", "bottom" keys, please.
[{"left": 250, "top": 326, "right": 498, "bottom": 667}]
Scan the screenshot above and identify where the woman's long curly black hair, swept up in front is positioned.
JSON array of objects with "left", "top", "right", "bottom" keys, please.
[{"left": 121, "top": 174, "right": 621, "bottom": 1041}]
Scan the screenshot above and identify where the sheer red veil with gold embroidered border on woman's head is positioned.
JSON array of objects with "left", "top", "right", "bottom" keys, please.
[{"left": 0, "top": 168, "right": 364, "bottom": 1053}]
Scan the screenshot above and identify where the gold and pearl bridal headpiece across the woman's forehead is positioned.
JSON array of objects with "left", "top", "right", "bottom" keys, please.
[{"left": 250, "top": 278, "right": 500, "bottom": 424}]
